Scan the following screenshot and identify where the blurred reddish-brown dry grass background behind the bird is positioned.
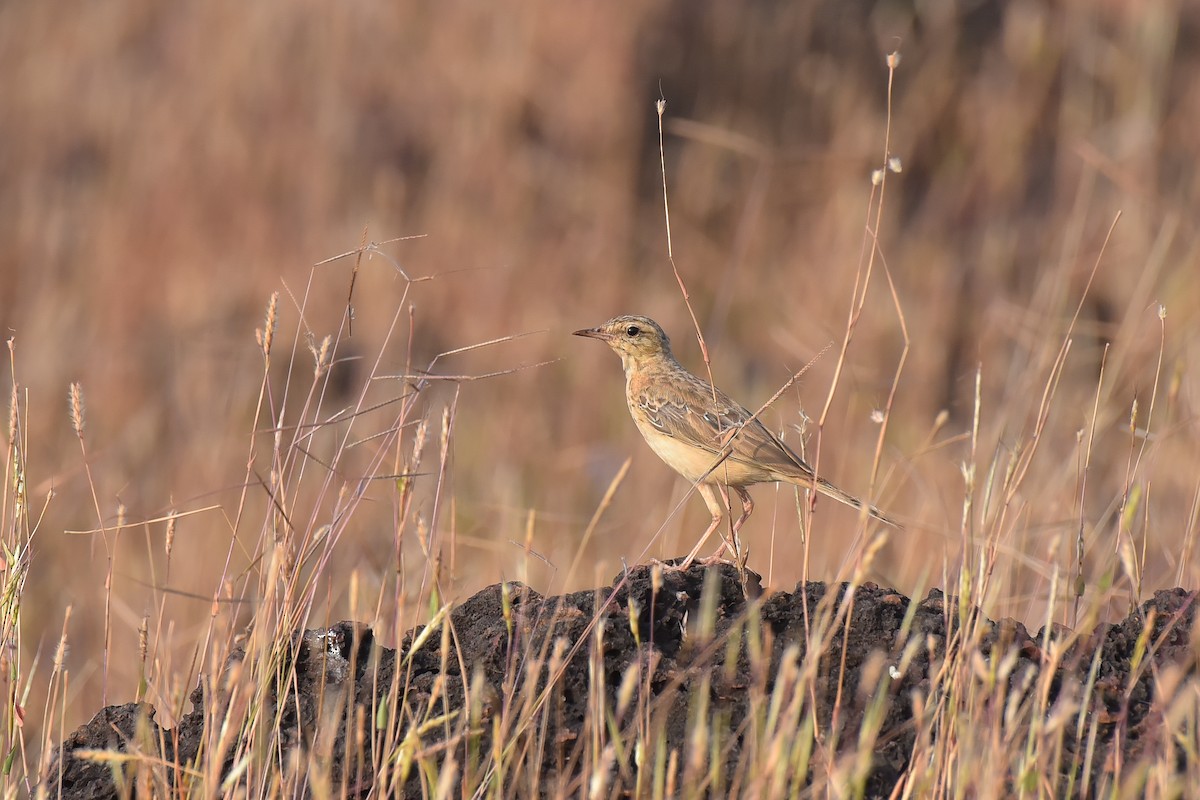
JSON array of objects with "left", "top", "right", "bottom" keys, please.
[{"left": 0, "top": 0, "right": 1200, "bottom": 762}]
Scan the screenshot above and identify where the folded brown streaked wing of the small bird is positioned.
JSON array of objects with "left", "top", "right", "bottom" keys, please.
[{"left": 637, "top": 374, "right": 812, "bottom": 479}]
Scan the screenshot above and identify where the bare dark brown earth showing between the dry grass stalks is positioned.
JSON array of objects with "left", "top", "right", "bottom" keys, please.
[{"left": 44, "top": 565, "right": 1196, "bottom": 799}]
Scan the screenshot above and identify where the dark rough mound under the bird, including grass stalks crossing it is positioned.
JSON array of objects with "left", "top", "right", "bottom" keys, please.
[{"left": 44, "top": 566, "right": 1196, "bottom": 798}]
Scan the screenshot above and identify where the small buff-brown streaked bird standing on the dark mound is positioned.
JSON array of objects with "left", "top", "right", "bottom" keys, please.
[{"left": 575, "top": 317, "right": 896, "bottom": 561}]
